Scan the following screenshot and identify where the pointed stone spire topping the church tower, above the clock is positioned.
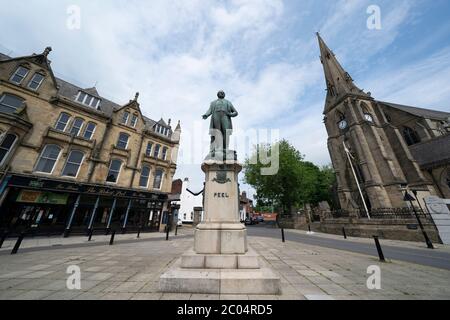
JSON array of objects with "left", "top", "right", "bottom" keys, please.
[{"left": 317, "top": 33, "right": 370, "bottom": 110}]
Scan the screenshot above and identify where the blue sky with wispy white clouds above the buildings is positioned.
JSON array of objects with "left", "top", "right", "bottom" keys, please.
[{"left": 0, "top": 0, "right": 450, "bottom": 196}]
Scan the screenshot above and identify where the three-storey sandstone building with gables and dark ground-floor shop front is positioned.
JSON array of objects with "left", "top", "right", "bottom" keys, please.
[{"left": 0, "top": 48, "right": 181, "bottom": 233}]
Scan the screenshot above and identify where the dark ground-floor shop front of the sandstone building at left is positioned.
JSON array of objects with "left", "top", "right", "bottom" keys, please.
[{"left": 0, "top": 175, "right": 167, "bottom": 235}]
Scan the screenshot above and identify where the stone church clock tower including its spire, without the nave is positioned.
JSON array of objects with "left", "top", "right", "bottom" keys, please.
[{"left": 317, "top": 34, "right": 429, "bottom": 211}]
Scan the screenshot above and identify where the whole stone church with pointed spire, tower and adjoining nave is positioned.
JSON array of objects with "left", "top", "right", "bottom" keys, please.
[{"left": 318, "top": 34, "right": 450, "bottom": 211}]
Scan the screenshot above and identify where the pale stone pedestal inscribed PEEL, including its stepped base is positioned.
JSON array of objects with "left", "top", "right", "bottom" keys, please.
[{"left": 160, "top": 159, "right": 280, "bottom": 295}]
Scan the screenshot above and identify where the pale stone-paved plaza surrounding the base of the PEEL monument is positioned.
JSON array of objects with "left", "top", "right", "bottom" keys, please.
[{"left": 0, "top": 228, "right": 450, "bottom": 300}]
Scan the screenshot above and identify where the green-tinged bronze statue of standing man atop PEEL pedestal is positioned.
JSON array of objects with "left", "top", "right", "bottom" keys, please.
[{"left": 203, "top": 91, "right": 238, "bottom": 154}]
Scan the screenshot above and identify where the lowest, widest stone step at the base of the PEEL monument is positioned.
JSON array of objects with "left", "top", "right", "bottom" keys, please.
[{"left": 159, "top": 259, "right": 281, "bottom": 295}]
